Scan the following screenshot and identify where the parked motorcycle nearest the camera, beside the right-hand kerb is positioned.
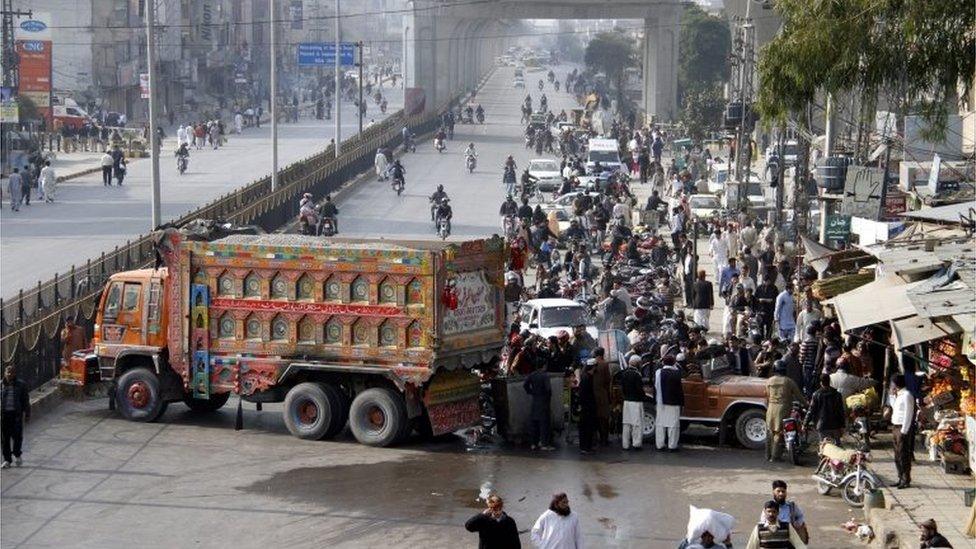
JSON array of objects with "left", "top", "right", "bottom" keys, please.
[{"left": 812, "top": 440, "right": 881, "bottom": 508}]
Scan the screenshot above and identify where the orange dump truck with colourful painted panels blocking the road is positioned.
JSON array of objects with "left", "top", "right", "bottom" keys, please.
[{"left": 60, "top": 229, "right": 505, "bottom": 446}]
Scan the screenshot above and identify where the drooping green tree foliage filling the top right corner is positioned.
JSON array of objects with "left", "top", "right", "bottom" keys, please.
[{"left": 757, "top": 0, "right": 976, "bottom": 136}]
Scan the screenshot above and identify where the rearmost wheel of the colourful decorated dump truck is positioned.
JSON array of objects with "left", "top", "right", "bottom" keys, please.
[{"left": 349, "top": 387, "right": 407, "bottom": 446}]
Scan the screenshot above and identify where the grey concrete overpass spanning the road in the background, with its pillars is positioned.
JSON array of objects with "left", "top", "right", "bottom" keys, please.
[{"left": 403, "top": 0, "right": 687, "bottom": 120}]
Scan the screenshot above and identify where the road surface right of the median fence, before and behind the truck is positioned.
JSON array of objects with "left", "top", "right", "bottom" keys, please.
[{"left": 0, "top": 69, "right": 854, "bottom": 549}]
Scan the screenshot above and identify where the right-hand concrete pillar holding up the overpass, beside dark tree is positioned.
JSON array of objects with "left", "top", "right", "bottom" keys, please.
[{"left": 642, "top": 7, "right": 681, "bottom": 121}]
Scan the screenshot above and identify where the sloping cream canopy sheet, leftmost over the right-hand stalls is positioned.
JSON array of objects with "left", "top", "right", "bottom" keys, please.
[{"left": 825, "top": 275, "right": 923, "bottom": 332}]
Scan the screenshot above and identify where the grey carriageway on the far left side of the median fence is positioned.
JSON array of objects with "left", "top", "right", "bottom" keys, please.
[{"left": 0, "top": 87, "right": 403, "bottom": 298}]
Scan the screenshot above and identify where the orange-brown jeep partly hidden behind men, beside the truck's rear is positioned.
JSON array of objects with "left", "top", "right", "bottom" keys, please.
[{"left": 612, "top": 345, "right": 767, "bottom": 450}]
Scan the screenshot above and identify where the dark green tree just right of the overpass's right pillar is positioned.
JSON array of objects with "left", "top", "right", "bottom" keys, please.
[{"left": 678, "top": 4, "right": 732, "bottom": 100}]
